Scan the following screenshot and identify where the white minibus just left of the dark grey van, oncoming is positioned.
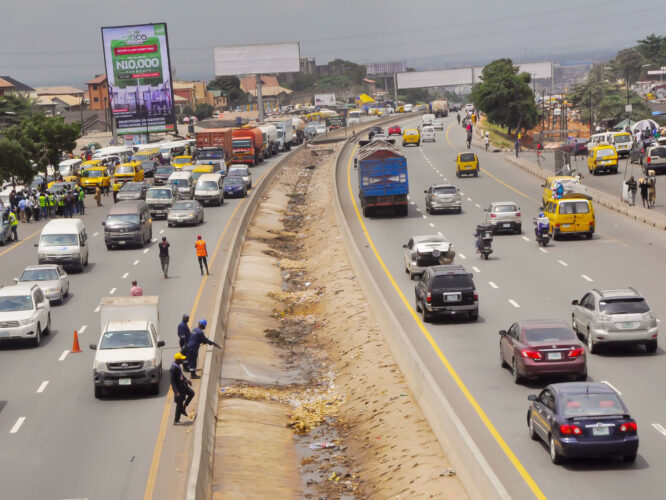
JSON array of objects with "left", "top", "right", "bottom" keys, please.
[{"left": 35, "top": 219, "right": 88, "bottom": 271}]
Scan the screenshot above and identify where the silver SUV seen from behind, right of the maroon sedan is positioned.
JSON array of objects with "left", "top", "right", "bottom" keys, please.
[{"left": 571, "top": 288, "right": 658, "bottom": 353}]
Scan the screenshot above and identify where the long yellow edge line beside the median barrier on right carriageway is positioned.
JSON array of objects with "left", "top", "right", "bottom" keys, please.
[{"left": 347, "top": 144, "right": 546, "bottom": 500}]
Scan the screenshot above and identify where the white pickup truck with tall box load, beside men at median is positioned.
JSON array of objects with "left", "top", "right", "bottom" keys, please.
[{"left": 90, "top": 296, "right": 164, "bottom": 398}]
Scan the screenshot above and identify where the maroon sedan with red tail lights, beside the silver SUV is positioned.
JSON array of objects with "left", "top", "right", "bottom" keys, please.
[{"left": 499, "top": 319, "right": 587, "bottom": 384}]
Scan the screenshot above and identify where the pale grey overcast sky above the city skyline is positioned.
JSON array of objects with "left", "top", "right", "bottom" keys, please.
[{"left": 0, "top": 0, "right": 666, "bottom": 87}]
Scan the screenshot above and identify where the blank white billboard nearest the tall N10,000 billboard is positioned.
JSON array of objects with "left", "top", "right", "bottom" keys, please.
[{"left": 213, "top": 43, "right": 301, "bottom": 76}]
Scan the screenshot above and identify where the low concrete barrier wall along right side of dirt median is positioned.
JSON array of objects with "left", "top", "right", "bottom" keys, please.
[{"left": 332, "top": 143, "right": 510, "bottom": 499}]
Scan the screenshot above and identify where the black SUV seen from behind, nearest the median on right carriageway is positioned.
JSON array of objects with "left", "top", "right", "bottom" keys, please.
[{"left": 414, "top": 264, "right": 479, "bottom": 322}]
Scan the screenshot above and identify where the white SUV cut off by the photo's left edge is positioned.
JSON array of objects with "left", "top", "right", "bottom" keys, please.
[{"left": 0, "top": 284, "right": 51, "bottom": 346}]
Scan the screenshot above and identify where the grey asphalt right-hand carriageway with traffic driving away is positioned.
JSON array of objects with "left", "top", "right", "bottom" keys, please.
[{"left": 336, "top": 117, "right": 666, "bottom": 499}]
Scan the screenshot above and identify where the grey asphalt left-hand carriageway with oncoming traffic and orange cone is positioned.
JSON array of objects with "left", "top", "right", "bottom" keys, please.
[{"left": 0, "top": 155, "right": 284, "bottom": 500}]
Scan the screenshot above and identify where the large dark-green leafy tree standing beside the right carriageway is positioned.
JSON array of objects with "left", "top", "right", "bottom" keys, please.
[{"left": 471, "top": 59, "right": 539, "bottom": 134}]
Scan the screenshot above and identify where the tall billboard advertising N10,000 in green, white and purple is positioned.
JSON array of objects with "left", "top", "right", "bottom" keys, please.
[{"left": 102, "top": 23, "right": 176, "bottom": 135}]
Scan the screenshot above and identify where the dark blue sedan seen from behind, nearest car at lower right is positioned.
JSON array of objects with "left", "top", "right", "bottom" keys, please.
[{"left": 527, "top": 382, "right": 638, "bottom": 464}]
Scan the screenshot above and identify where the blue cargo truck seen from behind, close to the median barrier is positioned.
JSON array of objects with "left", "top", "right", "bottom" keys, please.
[{"left": 355, "top": 139, "right": 409, "bottom": 217}]
